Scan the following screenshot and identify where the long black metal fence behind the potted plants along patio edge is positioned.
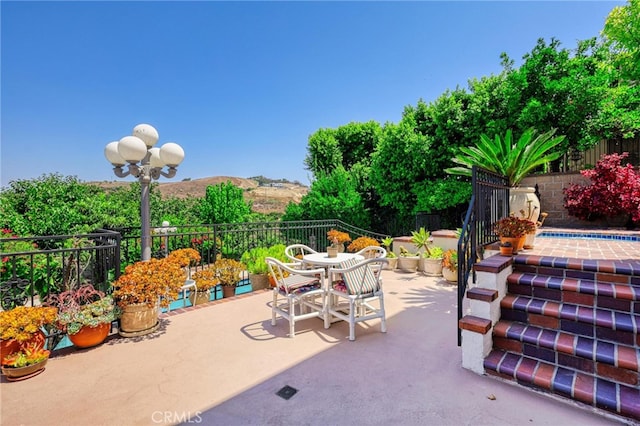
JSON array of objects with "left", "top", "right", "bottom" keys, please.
[{"left": 0, "top": 220, "right": 387, "bottom": 310}]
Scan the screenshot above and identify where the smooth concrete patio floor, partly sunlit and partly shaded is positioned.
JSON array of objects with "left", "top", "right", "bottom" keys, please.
[{"left": 0, "top": 235, "right": 640, "bottom": 426}]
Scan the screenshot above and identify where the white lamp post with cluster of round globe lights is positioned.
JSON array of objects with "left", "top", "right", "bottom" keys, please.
[{"left": 104, "top": 124, "right": 184, "bottom": 260}]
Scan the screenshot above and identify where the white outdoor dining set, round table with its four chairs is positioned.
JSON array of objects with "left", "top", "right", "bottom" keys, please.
[{"left": 266, "top": 244, "right": 388, "bottom": 341}]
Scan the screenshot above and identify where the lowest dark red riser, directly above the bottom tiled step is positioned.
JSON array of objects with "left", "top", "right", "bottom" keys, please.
[{"left": 493, "top": 337, "right": 640, "bottom": 386}]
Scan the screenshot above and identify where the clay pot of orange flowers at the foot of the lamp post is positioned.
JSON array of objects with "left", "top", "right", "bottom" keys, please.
[{"left": 113, "top": 249, "right": 197, "bottom": 337}]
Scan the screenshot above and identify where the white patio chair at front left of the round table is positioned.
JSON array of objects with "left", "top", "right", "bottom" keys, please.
[{"left": 265, "top": 257, "right": 329, "bottom": 337}]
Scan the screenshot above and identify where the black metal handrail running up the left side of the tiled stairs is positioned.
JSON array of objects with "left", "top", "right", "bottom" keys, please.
[{"left": 458, "top": 166, "right": 509, "bottom": 346}]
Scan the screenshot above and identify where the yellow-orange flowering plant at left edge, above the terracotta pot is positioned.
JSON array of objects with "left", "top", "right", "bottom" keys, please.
[{"left": 0, "top": 306, "right": 58, "bottom": 342}]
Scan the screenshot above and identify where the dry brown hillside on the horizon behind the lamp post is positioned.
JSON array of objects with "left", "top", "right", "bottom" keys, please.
[{"left": 89, "top": 176, "right": 309, "bottom": 213}]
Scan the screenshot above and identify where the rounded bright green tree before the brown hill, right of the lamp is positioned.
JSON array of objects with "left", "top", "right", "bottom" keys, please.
[{"left": 200, "top": 181, "right": 251, "bottom": 224}]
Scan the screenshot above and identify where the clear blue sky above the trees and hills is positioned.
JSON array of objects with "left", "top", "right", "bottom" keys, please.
[{"left": 0, "top": 1, "right": 625, "bottom": 186}]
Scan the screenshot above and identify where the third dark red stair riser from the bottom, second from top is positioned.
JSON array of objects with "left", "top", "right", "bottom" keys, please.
[{"left": 507, "top": 283, "right": 640, "bottom": 315}]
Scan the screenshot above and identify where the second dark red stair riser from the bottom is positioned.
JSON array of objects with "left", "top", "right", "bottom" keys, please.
[{"left": 501, "top": 307, "right": 640, "bottom": 346}]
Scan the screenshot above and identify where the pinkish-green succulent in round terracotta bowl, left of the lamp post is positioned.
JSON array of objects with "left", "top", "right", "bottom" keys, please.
[{"left": 46, "top": 284, "right": 120, "bottom": 348}]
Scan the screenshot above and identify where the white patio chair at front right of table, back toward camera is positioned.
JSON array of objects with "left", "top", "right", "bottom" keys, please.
[{"left": 327, "top": 258, "right": 389, "bottom": 341}]
